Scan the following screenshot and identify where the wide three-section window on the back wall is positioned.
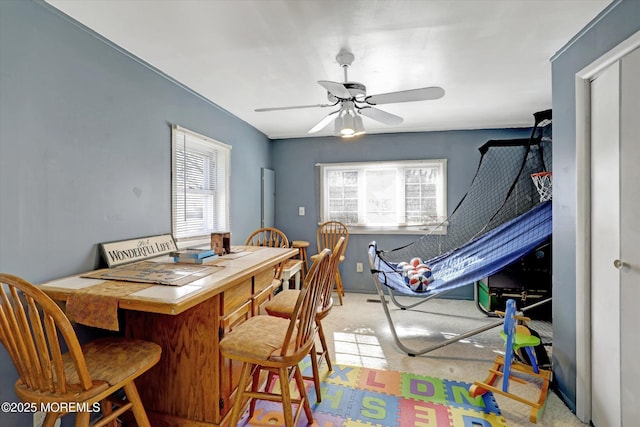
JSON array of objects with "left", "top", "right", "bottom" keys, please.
[{"left": 317, "top": 159, "right": 447, "bottom": 233}]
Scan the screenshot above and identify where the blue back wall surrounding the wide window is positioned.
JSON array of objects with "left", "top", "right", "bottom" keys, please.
[{"left": 273, "top": 128, "right": 533, "bottom": 298}]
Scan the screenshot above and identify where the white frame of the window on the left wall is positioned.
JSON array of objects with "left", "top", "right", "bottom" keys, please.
[{"left": 171, "top": 125, "right": 231, "bottom": 248}]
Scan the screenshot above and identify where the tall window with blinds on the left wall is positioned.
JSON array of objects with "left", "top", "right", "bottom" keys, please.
[{"left": 171, "top": 125, "right": 231, "bottom": 246}]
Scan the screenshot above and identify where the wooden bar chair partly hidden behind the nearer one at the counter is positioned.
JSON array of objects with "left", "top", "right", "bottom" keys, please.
[{"left": 265, "top": 237, "right": 346, "bottom": 402}]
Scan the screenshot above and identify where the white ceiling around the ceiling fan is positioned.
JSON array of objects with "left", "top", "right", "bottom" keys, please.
[{"left": 46, "top": 0, "right": 610, "bottom": 138}]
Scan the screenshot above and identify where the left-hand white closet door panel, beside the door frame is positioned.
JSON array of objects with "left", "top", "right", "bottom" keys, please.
[{"left": 591, "top": 57, "right": 620, "bottom": 427}]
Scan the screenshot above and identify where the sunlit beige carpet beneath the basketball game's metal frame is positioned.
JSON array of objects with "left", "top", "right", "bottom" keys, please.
[{"left": 322, "top": 292, "right": 588, "bottom": 427}]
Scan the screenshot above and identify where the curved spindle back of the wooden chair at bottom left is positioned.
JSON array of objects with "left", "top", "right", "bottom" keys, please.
[{"left": 0, "top": 274, "right": 92, "bottom": 393}]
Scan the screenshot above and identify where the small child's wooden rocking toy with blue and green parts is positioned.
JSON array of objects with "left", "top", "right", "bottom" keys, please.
[{"left": 469, "top": 299, "right": 551, "bottom": 423}]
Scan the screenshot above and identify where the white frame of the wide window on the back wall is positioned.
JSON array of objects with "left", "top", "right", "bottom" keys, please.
[{"left": 316, "top": 159, "right": 447, "bottom": 234}]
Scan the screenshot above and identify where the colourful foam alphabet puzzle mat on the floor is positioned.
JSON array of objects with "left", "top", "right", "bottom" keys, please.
[{"left": 239, "top": 362, "right": 506, "bottom": 427}]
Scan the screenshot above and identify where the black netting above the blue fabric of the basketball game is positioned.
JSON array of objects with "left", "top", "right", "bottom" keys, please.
[{"left": 379, "top": 110, "right": 552, "bottom": 263}]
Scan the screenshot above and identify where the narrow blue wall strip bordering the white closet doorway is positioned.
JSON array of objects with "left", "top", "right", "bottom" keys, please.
[{"left": 552, "top": 0, "right": 640, "bottom": 409}]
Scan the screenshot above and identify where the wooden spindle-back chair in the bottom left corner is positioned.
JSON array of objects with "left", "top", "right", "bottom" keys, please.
[{"left": 0, "top": 274, "right": 162, "bottom": 427}]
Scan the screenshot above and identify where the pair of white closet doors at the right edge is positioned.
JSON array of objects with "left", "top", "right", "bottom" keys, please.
[{"left": 591, "top": 45, "right": 640, "bottom": 427}]
